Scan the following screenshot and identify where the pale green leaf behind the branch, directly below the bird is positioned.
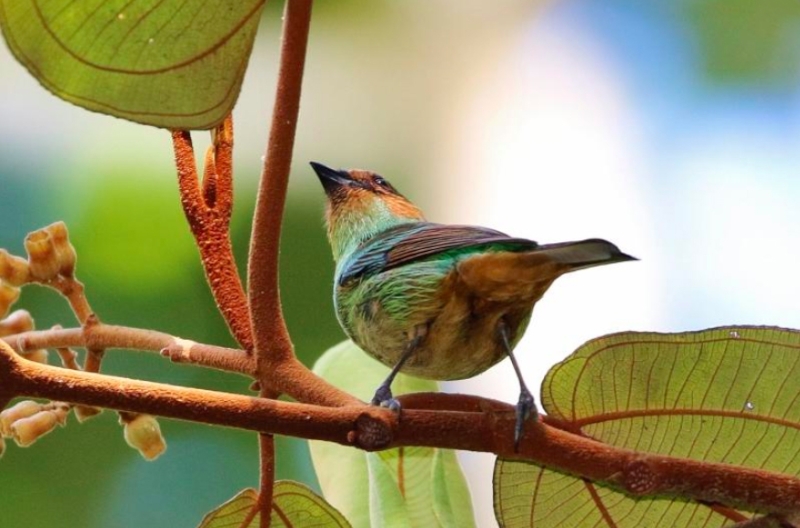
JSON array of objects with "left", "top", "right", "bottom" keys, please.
[{"left": 309, "top": 341, "right": 475, "bottom": 528}]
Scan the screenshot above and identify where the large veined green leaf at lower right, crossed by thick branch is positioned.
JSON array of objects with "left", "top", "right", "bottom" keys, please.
[{"left": 495, "top": 327, "right": 800, "bottom": 527}]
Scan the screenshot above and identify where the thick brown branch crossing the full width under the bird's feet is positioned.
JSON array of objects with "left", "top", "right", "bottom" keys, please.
[{"left": 0, "top": 344, "right": 800, "bottom": 517}]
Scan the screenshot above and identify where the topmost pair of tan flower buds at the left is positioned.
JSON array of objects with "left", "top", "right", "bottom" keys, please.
[{"left": 25, "top": 222, "right": 77, "bottom": 281}]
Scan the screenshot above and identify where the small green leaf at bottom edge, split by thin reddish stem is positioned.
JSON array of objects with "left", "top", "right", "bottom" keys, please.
[{"left": 198, "top": 480, "right": 350, "bottom": 528}]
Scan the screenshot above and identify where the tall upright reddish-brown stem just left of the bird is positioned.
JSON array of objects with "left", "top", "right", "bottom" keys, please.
[{"left": 247, "top": 0, "right": 360, "bottom": 405}]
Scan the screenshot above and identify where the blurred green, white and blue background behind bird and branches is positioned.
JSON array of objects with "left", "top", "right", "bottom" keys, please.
[{"left": 0, "top": 0, "right": 800, "bottom": 527}]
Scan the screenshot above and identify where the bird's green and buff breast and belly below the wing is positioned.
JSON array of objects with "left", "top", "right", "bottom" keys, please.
[{"left": 334, "top": 262, "right": 532, "bottom": 380}]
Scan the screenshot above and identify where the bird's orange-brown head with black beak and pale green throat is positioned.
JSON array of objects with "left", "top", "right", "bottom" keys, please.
[{"left": 311, "top": 161, "right": 425, "bottom": 262}]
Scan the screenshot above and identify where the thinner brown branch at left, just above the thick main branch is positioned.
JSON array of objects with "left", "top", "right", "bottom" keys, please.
[{"left": 0, "top": 324, "right": 255, "bottom": 376}]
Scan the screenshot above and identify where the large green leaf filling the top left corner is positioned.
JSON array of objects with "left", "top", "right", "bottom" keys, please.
[{"left": 0, "top": 0, "right": 264, "bottom": 129}]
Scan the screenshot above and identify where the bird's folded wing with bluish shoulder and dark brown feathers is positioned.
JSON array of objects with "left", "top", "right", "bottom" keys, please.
[{"left": 339, "top": 222, "right": 538, "bottom": 284}]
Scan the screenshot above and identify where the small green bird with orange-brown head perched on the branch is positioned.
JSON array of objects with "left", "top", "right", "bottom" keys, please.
[{"left": 311, "top": 162, "right": 638, "bottom": 449}]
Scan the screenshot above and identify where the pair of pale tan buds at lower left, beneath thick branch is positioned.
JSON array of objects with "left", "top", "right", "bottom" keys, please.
[{"left": 0, "top": 400, "right": 69, "bottom": 447}]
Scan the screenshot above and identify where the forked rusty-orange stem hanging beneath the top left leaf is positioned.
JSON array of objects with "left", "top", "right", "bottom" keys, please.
[{"left": 172, "top": 116, "right": 253, "bottom": 351}]
